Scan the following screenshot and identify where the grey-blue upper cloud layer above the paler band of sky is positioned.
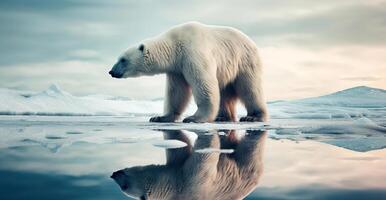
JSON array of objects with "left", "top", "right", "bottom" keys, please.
[{"left": 0, "top": 0, "right": 386, "bottom": 64}]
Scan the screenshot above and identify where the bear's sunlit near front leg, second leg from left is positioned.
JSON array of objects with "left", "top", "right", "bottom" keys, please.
[{"left": 183, "top": 66, "right": 220, "bottom": 123}]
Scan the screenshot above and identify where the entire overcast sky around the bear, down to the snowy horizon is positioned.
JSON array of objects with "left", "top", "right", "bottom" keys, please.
[{"left": 0, "top": 0, "right": 386, "bottom": 100}]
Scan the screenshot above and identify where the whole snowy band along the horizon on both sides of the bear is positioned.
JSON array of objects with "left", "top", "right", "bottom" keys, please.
[{"left": 0, "top": 84, "right": 386, "bottom": 119}]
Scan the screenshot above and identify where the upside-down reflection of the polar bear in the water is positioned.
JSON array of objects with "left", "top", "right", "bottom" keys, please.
[{"left": 112, "top": 130, "right": 265, "bottom": 200}]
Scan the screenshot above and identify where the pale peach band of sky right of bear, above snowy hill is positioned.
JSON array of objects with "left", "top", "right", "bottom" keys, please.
[{"left": 260, "top": 46, "right": 386, "bottom": 100}]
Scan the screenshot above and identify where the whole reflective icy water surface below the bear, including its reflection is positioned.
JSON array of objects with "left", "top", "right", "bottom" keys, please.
[{"left": 0, "top": 116, "right": 386, "bottom": 199}]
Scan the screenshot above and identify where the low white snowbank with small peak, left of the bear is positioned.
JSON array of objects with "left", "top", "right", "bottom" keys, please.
[{"left": 0, "top": 85, "right": 163, "bottom": 116}]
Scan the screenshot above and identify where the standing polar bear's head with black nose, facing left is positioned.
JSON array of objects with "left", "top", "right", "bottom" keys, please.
[{"left": 109, "top": 44, "right": 147, "bottom": 78}]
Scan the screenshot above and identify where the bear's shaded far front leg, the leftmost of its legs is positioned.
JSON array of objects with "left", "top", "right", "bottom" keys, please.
[{"left": 150, "top": 73, "right": 192, "bottom": 122}]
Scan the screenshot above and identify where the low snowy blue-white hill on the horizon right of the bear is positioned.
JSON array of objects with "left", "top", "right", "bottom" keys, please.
[{"left": 269, "top": 86, "right": 386, "bottom": 119}]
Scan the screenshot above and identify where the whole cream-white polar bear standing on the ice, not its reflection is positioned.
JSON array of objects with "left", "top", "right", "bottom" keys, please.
[{"left": 109, "top": 22, "right": 267, "bottom": 123}]
